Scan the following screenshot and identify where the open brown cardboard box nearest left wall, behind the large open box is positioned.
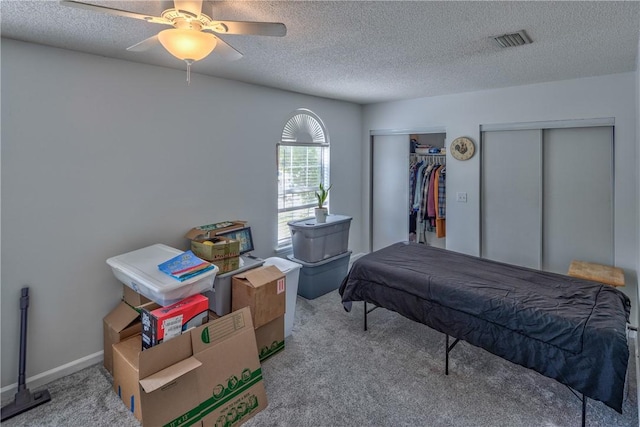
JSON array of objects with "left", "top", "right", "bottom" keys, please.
[{"left": 102, "top": 302, "right": 142, "bottom": 375}]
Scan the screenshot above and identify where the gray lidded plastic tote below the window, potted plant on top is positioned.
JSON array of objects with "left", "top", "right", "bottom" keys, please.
[{"left": 288, "top": 215, "right": 351, "bottom": 262}]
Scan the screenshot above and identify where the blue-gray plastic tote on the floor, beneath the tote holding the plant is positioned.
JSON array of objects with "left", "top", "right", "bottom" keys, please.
[{"left": 288, "top": 251, "right": 351, "bottom": 299}]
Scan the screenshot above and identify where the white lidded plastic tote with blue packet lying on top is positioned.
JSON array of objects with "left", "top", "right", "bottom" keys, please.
[{"left": 107, "top": 244, "right": 219, "bottom": 306}]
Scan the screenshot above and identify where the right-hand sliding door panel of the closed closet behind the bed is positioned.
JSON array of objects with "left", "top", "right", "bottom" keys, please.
[{"left": 542, "top": 127, "right": 613, "bottom": 273}]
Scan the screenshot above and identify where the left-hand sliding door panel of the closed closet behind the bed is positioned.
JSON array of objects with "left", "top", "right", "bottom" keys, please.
[{"left": 481, "top": 130, "right": 542, "bottom": 268}]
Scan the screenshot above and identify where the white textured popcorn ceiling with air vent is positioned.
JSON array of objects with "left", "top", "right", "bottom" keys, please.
[{"left": 0, "top": 0, "right": 640, "bottom": 104}]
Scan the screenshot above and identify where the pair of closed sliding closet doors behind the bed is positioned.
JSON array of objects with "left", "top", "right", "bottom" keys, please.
[{"left": 481, "top": 125, "right": 614, "bottom": 274}]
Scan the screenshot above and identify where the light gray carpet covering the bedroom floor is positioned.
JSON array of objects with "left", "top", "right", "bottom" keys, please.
[{"left": 2, "top": 291, "right": 638, "bottom": 427}]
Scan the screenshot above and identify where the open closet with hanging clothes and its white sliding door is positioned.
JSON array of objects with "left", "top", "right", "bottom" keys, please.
[{"left": 369, "top": 128, "right": 446, "bottom": 251}]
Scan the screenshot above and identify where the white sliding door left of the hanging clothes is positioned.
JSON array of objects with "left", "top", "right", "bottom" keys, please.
[{"left": 371, "top": 135, "right": 410, "bottom": 250}]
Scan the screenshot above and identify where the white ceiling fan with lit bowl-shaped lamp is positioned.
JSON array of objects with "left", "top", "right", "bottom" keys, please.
[{"left": 60, "top": 0, "right": 287, "bottom": 81}]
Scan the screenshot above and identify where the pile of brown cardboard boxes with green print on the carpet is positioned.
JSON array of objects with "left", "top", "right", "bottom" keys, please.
[{"left": 104, "top": 266, "right": 286, "bottom": 426}]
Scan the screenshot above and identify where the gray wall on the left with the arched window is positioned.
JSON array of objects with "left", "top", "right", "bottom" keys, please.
[{"left": 1, "top": 39, "right": 363, "bottom": 388}]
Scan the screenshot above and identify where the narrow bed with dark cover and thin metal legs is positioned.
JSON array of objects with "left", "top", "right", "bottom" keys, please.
[{"left": 339, "top": 242, "right": 631, "bottom": 425}]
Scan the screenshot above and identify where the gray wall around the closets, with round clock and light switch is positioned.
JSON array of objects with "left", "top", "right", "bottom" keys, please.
[{"left": 362, "top": 72, "right": 640, "bottom": 325}]
